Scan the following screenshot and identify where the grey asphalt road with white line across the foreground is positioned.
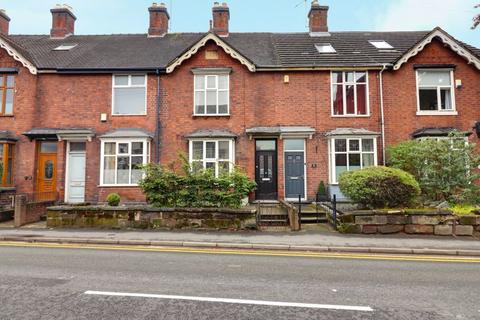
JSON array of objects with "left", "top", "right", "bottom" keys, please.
[{"left": 0, "top": 243, "right": 480, "bottom": 320}]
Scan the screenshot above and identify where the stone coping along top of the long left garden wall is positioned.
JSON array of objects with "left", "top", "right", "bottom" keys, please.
[{"left": 47, "top": 205, "right": 257, "bottom": 214}]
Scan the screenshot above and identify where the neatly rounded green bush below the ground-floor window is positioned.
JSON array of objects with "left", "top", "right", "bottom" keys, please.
[{"left": 339, "top": 167, "right": 420, "bottom": 208}]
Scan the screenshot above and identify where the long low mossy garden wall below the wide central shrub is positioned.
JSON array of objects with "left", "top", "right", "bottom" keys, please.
[{"left": 47, "top": 206, "right": 256, "bottom": 230}]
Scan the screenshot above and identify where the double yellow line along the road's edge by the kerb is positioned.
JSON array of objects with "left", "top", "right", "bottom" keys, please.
[{"left": 0, "top": 242, "right": 480, "bottom": 264}]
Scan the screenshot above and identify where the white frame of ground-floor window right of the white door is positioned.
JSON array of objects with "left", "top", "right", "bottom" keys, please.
[{"left": 100, "top": 138, "right": 150, "bottom": 187}]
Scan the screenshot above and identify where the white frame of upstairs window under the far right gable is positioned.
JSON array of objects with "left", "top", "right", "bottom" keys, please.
[{"left": 415, "top": 68, "right": 458, "bottom": 116}]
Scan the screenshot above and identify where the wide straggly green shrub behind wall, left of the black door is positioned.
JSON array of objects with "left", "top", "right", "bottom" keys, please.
[{"left": 139, "top": 157, "right": 256, "bottom": 208}]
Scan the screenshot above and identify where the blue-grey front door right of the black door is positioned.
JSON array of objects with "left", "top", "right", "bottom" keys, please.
[{"left": 285, "top": 152, "right": 305, "bottom": 199}]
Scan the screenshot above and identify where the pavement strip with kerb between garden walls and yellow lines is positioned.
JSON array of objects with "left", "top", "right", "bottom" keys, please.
[{"left": 0, "top": 227, "right": 480, "bottom": 256}]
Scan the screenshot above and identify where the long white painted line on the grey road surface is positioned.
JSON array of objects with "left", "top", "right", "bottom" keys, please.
[{"left": 84, "top": 291, "right": 373, "bottom": 312}]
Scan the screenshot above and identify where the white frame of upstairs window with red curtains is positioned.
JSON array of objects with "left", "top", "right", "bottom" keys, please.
[{"left": 330, "top": 70, "right": 370, "bottom": 118}]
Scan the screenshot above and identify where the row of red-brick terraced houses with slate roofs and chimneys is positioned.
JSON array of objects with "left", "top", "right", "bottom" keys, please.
[{"left": 0, "top": 1, "right": 480, "bottom": 203}]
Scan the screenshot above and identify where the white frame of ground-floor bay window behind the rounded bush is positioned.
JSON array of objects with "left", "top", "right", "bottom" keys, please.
[{"left": 328, "top": 136, "right": 378, "bottom": 185}]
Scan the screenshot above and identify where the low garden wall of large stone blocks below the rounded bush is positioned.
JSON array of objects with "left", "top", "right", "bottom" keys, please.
[{"left": 339, "top": 210, "right": 480, "bottom": 236}]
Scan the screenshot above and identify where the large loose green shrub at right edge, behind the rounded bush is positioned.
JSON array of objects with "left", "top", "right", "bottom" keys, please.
[{"left": 388, "top": 134, "right": 480, "bottom": 203}]
